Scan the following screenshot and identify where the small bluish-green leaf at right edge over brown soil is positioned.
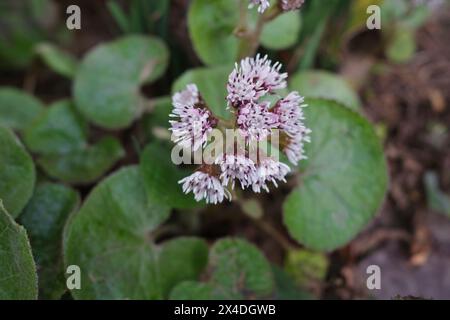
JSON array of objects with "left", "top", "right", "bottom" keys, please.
[{"left": 424, "top": 171, "right": 450, "bottom": 217}]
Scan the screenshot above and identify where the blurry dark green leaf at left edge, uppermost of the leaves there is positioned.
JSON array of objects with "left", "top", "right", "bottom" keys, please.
[{"left": 0, "top": 87, "right": 44, "bottom": 130}]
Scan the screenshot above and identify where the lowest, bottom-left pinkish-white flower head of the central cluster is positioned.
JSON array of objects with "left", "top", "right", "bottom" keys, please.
[{"left": 178, "top": 171, "right": 231, "bottom": 204}]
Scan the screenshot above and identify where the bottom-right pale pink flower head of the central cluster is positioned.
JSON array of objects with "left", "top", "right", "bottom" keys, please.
[{"left": 252, "top": 158, "right": 291, "bottom": 193}]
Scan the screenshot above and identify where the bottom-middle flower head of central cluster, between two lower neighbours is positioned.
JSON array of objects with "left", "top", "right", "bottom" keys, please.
[{"left": 216, "top": 154, "right": 257, "bottom": 189}]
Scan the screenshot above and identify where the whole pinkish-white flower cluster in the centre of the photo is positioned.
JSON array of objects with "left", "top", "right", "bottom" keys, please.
[{"left": 170, "top": 55, "right": 310, "bottom": 204}]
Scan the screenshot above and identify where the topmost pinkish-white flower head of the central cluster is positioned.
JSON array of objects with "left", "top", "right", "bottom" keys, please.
[{"left": 227, "top": 54, "right": 287, "bottom": 108}]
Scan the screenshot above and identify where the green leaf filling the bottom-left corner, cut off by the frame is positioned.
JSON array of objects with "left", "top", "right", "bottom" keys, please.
[{"left": 0, "top": 199, "right": 38, "bottom": 300}]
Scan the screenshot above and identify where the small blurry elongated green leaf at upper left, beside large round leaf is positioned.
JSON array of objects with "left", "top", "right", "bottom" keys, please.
[{"left": 35, "top": 43, "right": 78, "bottom": 79}]
